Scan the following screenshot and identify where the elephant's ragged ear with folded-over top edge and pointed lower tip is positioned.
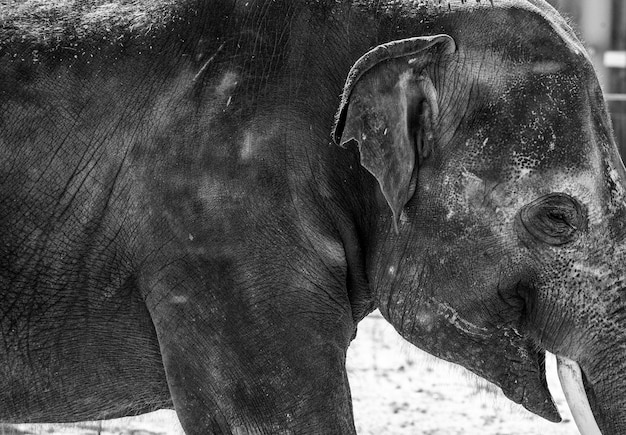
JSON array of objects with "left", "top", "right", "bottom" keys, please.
[{"left": 333, "top": 35, "right": 456, "bottom": 232}]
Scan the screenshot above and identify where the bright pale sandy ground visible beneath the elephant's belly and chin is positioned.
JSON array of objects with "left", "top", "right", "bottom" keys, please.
[{"left": 0, "top": 313, "right": 578, "bottom": 435}]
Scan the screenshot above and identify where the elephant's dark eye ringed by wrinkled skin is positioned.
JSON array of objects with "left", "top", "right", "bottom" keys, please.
[{"left": 518, "top": 193, "right": 587, "bottom": 246}]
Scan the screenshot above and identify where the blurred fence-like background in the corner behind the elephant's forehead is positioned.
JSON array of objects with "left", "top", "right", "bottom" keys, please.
[{"left": 548, "top": 0, "right": 626, "bottom": 160}]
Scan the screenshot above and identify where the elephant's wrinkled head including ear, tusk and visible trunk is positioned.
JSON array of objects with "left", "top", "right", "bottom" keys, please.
[{"left": 334, "top": 2, "right": 626, "bottom": 435}]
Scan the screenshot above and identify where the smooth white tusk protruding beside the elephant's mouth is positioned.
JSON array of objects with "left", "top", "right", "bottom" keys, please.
[{"left": 556, "top": 355, "right": 602, "bottom": 435}]
